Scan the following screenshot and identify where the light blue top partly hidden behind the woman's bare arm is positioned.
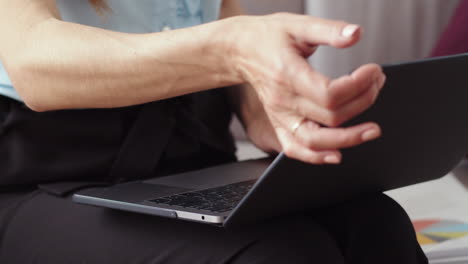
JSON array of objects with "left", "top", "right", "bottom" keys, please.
[{"left": 0, "top": 0, "right": 222, "bottom": 101}]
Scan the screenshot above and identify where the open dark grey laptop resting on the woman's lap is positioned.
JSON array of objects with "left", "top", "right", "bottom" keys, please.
[{"left": 73, "top": 54, "right": 468, "bottom": 227}]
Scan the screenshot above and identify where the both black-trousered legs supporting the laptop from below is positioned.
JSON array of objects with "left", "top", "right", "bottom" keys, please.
[{"left": 0, "top": 191, "right": 427, "bottom": 264}]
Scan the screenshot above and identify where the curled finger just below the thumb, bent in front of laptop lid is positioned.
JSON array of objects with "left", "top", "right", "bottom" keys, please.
[{"left": 328, "top": 64, "right": 385, "bottom": 110}]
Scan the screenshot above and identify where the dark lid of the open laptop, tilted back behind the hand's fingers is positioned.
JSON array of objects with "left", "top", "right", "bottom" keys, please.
[{"left": 224, "top": 54, "right": 468, "bottom": 227}]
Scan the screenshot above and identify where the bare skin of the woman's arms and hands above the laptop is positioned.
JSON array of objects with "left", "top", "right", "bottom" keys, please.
[{"left": 0, "top": 0, "right": 385, "bottom": 163}]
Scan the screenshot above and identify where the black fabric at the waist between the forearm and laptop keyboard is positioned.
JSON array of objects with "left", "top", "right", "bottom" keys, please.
[{"left": 0, "top": 89, "right": 235, "bottom": 195}]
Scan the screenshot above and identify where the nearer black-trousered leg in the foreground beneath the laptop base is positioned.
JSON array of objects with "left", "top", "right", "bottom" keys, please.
[{"left": 0, "top": 191, "right": 343, "bottom": 264}]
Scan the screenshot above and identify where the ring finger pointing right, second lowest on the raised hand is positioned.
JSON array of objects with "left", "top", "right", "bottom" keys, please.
[{"left": 295, "top": 121, "right": 382, "bottom": 151}]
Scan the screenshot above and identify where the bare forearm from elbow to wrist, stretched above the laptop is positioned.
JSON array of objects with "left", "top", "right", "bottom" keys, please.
[{"left": 2, "top": 18, "right": 241, "bottom": 111}]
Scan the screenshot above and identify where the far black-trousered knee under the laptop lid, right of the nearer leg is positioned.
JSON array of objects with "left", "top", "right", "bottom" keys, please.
[{"left": 314, "top": 194, "right": 428, "bottom": 264}]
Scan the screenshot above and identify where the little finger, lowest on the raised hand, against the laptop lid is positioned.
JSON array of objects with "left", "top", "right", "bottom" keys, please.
[{"left": 277, "top": 129, "right": 342, "bottom": 164}]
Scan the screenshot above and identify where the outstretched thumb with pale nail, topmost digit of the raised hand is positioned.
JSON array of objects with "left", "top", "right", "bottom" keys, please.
[{"left": 285, "top": 15, "right": 362, "bottom": 48}]
